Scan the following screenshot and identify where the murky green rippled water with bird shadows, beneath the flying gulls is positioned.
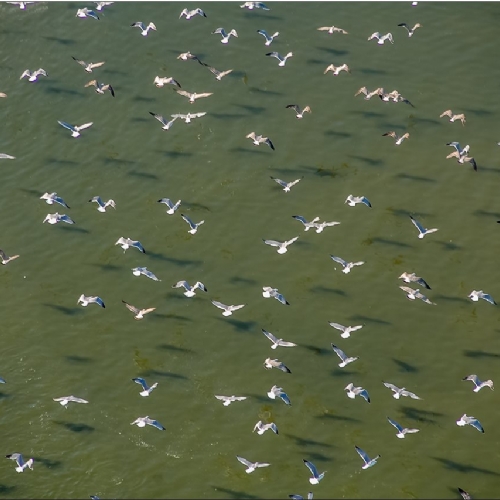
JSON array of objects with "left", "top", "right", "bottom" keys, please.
[{"left": 0, "top": 2, "right": 500, "bottom": 498}]
